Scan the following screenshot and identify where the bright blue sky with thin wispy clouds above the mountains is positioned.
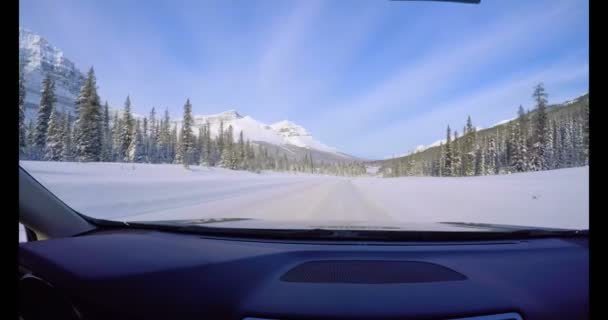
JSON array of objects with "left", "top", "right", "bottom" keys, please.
[{"left": 19, "top": 0, "right": 589, "bottom": 158}]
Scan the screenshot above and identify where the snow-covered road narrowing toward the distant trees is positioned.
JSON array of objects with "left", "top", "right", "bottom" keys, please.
[{"left": 117, "top": 177, "right": 392, "bottom": 221}]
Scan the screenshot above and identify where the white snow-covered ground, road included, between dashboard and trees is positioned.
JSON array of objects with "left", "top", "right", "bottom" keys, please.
[{"left": 21, "top": 161, "right": 589, "bottom": 228}]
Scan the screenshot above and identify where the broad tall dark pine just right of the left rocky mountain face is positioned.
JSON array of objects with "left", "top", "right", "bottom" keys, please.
[{"left": 75, "top": 67, "right": 102, "bottom": 162}]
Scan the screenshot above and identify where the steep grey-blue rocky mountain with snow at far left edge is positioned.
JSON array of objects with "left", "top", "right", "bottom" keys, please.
[{"left": 19, "top": 27, "right": 85, "bottom": 121}]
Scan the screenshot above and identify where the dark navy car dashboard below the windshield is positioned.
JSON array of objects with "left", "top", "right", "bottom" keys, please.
[{"left": 19, "top": 228, "right": 589, "bottom": 320}]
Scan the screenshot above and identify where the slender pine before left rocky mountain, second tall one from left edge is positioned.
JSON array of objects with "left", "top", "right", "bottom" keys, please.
[{"left": 33, "top": 74, "right": 57, "bottom": 160}]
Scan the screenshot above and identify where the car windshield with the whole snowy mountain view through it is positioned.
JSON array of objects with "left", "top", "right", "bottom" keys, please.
[{"left": 19, "top": 0, "right": 589, "bottom": 232}]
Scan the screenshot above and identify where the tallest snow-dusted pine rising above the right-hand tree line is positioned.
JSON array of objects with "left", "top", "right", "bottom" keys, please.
[{"left": 530, "top": 83, "right": 548, "bottom": 170}]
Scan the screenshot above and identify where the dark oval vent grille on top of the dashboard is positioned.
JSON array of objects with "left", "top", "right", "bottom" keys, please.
[{"left": 281, "top": 260, "right": 467, "bottom": 284}]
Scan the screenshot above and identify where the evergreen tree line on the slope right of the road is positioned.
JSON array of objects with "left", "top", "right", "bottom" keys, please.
[{"left": 380, "top": 83, "right": 589, "bottom": 177}]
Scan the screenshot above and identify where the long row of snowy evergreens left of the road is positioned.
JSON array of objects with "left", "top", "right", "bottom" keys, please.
[{"left": 19, "top": 67, "right": 366, "bottom": 176}]
